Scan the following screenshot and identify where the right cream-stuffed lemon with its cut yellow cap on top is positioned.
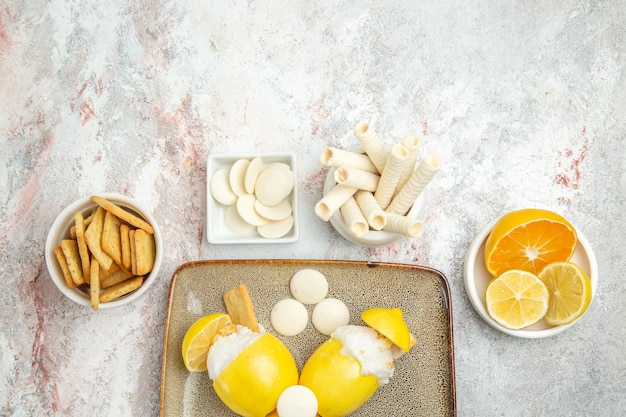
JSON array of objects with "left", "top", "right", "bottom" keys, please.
[{"left": 299, "top": 308, "right": 416, "bottom": 417}]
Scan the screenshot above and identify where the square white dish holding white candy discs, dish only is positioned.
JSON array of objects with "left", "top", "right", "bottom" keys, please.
[{"left": 206, "top": 152, "right": 299, "bottom": 244}]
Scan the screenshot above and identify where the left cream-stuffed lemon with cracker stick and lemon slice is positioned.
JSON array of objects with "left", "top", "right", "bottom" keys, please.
[{"left": 182, "top": 285, "right": 298, "bottom": 417}]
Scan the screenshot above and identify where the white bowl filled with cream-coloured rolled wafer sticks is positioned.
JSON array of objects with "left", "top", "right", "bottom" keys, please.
[{"left": 315, "top": 123, "right": 441, "bottom": 247}]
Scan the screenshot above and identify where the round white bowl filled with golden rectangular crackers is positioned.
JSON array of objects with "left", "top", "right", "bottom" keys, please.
[{"left": 46, "top": 193, "right": 163, "bottom": 310}]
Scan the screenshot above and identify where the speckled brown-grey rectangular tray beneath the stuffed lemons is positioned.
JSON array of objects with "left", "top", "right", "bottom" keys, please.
[{"left": 160, "top": 260, "right": 456, "bottom": 417}]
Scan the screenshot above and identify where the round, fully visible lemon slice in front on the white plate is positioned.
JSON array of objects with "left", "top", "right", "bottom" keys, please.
[{"left": 485, "top": 269, "right": 549, "bottom": 330}]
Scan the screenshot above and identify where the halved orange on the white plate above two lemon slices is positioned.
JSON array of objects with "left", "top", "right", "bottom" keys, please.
[{"left": 485, "top": 208, "right": 577, "bottom": 277}]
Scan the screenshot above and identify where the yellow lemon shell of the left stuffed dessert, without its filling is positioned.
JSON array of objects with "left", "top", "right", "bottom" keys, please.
[{"left": 209, "top": 333, "right": 298, "bottom": 417}]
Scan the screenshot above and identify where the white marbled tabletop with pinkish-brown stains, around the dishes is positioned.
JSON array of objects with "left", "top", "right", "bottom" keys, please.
[{"left": 0, "top": 0, "right": 626, "bottom": 417}]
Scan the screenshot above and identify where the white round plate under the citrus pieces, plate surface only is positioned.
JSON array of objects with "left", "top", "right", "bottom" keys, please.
[{"left": 463, "top": 220, "right": 598, "bottom": 339}]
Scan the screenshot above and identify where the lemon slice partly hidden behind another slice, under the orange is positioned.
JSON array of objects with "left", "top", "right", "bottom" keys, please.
[{"left": 539, "top": 262, "right": 591, "bottom": 326}]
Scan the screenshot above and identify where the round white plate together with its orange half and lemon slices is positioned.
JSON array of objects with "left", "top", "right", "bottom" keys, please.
[{"left": 464, "top": 208, "right": 598, "bottom": 338}]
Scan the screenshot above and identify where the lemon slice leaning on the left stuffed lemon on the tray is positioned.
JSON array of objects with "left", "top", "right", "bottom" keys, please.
[{"left": 182, "top": 313, "right": 231, "bottom": 372}]
